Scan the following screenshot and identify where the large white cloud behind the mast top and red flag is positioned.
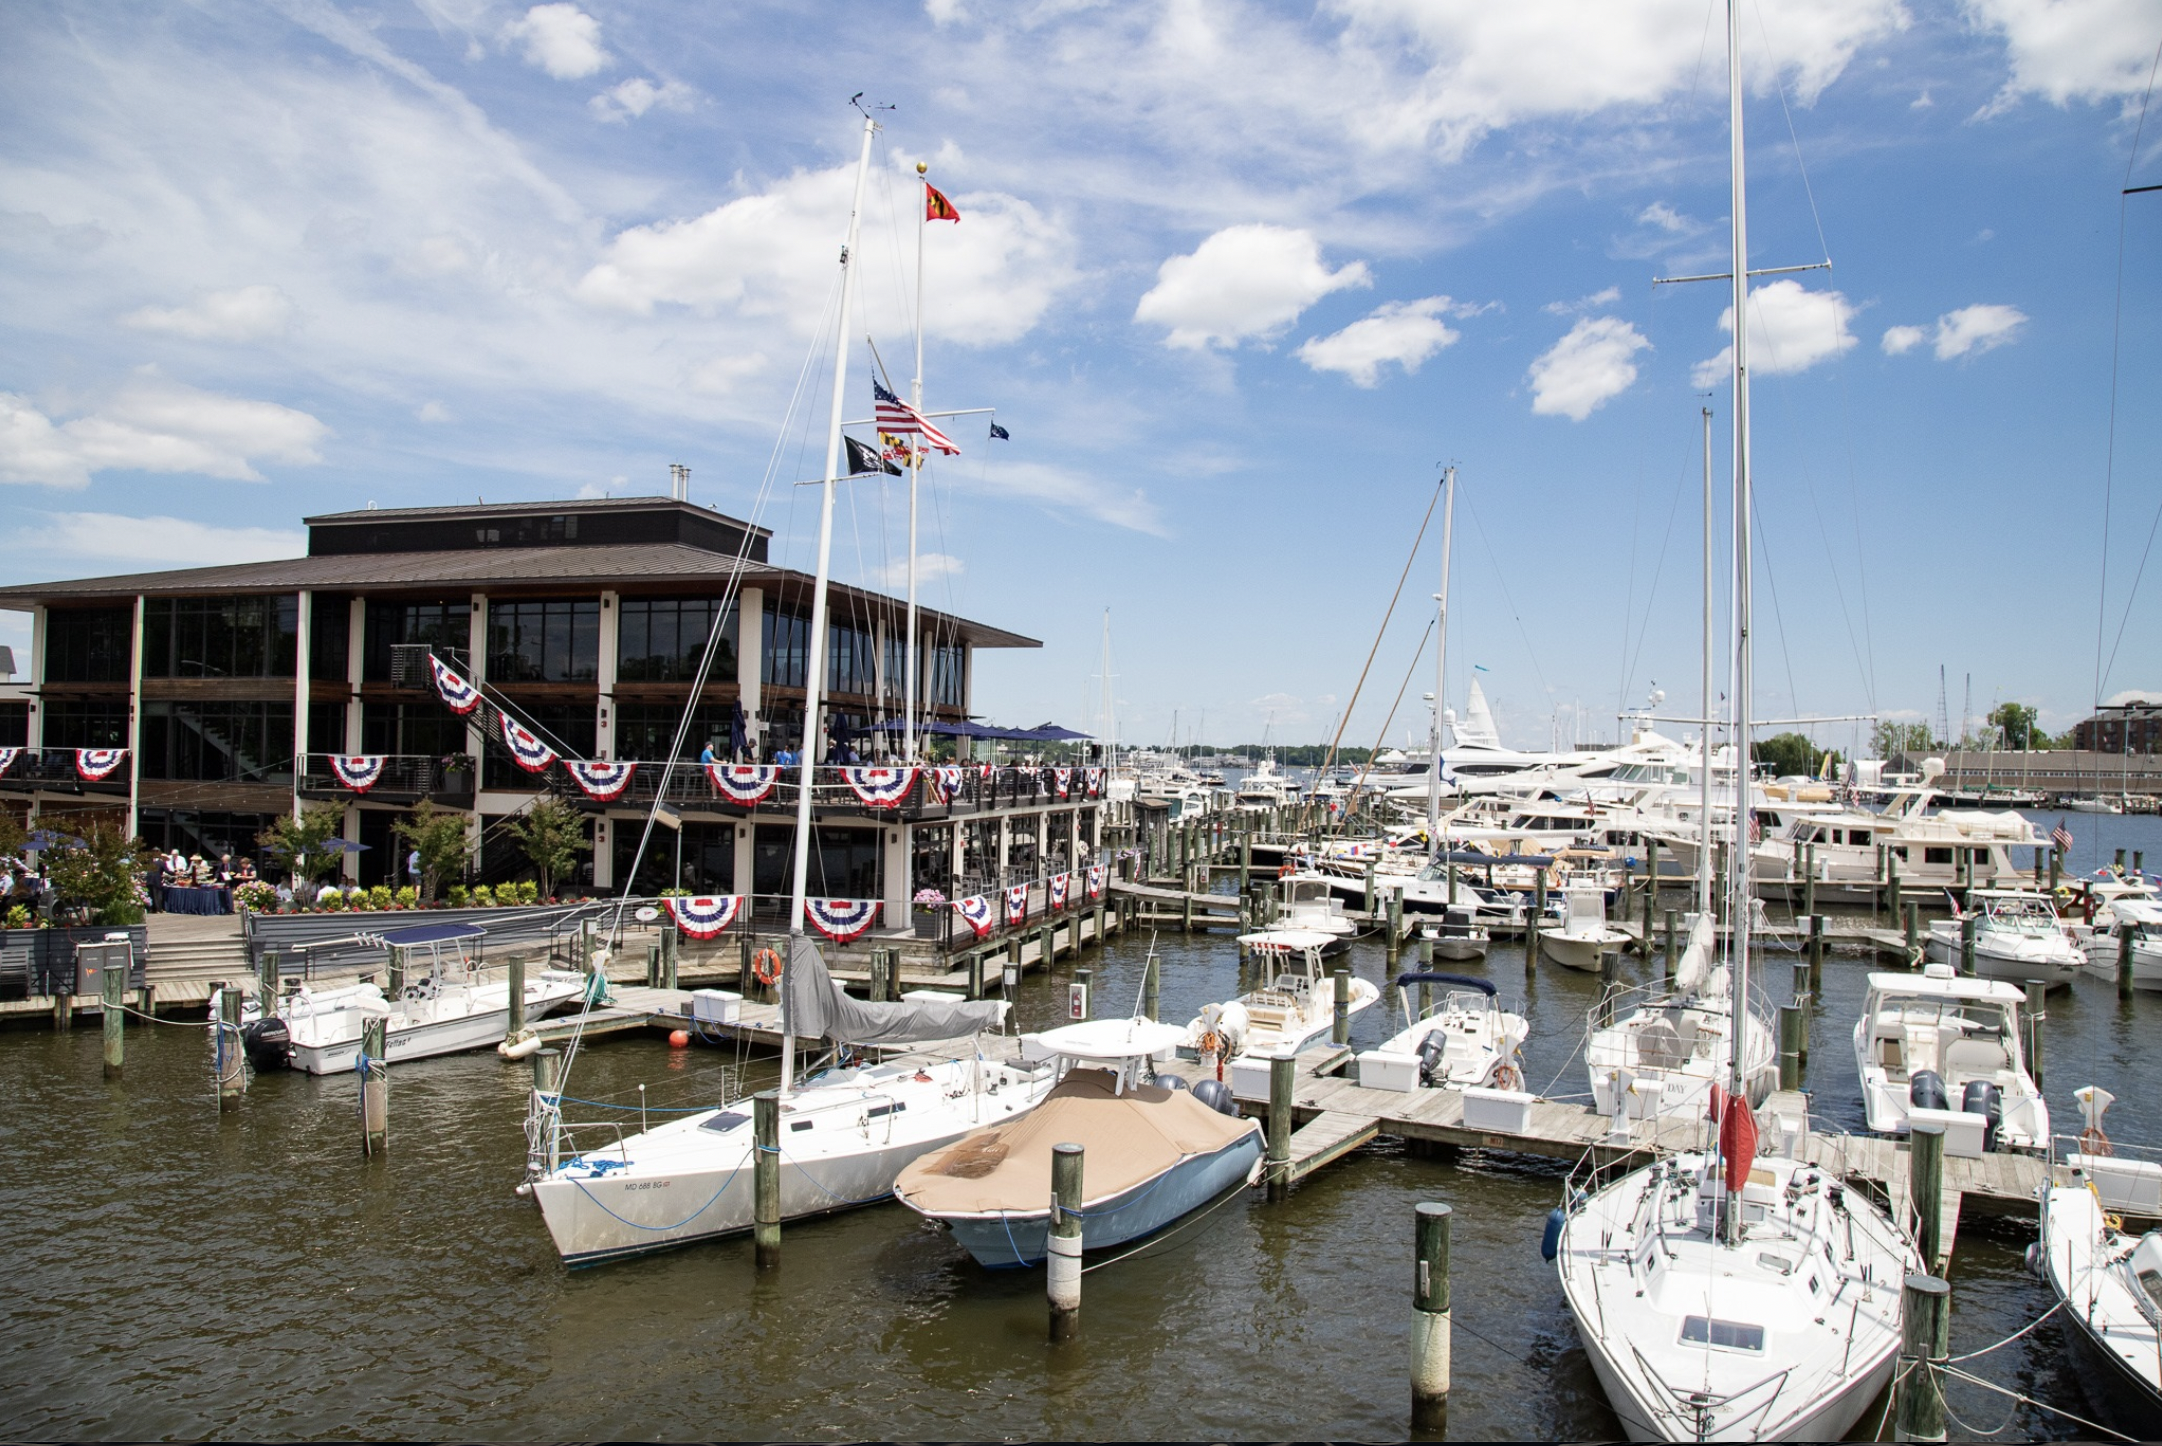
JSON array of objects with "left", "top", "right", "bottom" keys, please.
[{"left": 575, "top": 166, "right": 1079, "bottom": 346}]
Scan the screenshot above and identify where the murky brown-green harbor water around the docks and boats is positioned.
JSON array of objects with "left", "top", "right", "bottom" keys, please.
[{"left": 0, "top": 819, "right": 2162, "bottom": 1440}]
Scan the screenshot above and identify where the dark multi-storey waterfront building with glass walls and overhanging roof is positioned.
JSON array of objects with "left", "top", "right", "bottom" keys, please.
[{"left": 0, "top": 497, "right": 1100, "bottom": 925}]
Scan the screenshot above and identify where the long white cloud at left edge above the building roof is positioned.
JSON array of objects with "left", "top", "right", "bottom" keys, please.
[{"left": 0, "top": 367, "right": 331, "bottom": 486}]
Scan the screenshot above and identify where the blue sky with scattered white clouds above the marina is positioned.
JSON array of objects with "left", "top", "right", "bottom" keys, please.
[{"left": 0, "top": 0, "right": 2162, "bottom": 746}]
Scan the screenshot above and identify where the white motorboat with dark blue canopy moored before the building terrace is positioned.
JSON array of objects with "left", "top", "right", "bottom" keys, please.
[{"left": 240, "top": 923, "right": 590, "bottom": 1074}]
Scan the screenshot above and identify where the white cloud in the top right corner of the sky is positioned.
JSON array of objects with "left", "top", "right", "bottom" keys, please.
[{"left": 1965, "top": 0, "right": 2162, "bottom": 110}]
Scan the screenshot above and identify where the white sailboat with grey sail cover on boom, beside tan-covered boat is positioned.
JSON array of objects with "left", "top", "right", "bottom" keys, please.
[{"left": 521, "top": 115, "right": 1051, "bottom": 1264}]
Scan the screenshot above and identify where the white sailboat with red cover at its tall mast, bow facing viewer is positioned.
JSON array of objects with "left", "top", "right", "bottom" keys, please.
[{"left": 1546, "top": 0, "right": 1920, "bottom": 1442}]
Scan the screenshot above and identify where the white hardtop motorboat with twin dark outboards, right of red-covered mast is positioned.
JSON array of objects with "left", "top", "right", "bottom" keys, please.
[{"left": 1855, "top": 964, "right": 2050, "bottom": 1150}]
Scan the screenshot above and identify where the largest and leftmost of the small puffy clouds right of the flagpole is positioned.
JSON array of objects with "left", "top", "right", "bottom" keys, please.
[{"left": 1133, "top": 223, "right": 1373, "bottom": 350}]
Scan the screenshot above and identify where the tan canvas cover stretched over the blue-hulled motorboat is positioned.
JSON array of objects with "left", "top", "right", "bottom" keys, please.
[{"left": 893, "top": 1070, "right": 1258, "bottom": 1215}]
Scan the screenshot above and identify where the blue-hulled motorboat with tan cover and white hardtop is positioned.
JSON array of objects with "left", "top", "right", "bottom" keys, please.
[{"left": 893, "top": 1018, "right": 1263, "bottom": 1269}]
